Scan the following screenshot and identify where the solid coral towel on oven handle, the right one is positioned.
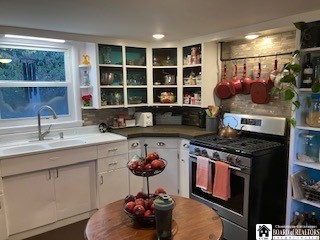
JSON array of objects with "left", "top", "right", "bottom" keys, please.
[{"left": 212, "top": 161, "right": 231, "bottom": 201}]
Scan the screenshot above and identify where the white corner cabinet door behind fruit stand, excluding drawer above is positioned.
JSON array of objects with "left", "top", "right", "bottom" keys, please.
[{"left": 148, "top": 148, "right": 179, "bottom": 195}]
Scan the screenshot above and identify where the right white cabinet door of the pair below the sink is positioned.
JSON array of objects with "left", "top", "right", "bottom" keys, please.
[{"left": 52, "top": 161, "right": 96, "bottom": 219}]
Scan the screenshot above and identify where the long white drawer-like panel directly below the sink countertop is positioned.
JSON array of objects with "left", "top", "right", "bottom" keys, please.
[{"left": 0, "top": 146, "right": 97, "bottom": 177}]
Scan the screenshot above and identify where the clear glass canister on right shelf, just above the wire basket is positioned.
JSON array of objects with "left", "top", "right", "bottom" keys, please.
[{"left": 299, "top": 132, "right": 319, "bottom": 162}]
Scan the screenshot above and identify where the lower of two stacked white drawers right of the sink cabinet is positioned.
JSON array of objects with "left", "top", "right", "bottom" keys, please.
[{"left": 98, "top": 154, "right": 128, "bottom": 173}]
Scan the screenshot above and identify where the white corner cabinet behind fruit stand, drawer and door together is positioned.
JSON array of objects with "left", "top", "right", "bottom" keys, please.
[{"left": 143, "top": 138, "right": 179, "bottom": 195}]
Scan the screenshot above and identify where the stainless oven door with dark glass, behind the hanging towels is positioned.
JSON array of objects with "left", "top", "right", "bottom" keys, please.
[{"left": 189, "top": 155, "right": 250, "bottom": 229}]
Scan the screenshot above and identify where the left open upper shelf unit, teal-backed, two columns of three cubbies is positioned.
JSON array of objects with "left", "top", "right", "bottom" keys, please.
[{"left": 98, "top": 44, "right": 148, "bottom": 108}]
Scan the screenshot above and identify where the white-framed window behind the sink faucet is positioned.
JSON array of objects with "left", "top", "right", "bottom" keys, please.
[{"left": 0, "top": 42, "right": 76, "bottom": 132}]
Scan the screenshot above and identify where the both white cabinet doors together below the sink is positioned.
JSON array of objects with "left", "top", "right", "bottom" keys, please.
[{"left": 3, "top": 161, "right": 96, "bottom": 235}]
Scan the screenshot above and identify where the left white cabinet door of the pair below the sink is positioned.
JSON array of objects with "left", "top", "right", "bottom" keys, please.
[{"left": 3, "top": 170, "right": 56, "bottom": 235}]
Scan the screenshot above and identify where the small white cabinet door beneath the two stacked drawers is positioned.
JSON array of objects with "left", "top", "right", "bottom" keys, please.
[{"left": 98, "top": 168, "right": 129, "bottom": 208}]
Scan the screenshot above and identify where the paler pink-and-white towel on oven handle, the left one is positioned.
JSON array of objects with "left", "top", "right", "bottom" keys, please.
[{"left": 196, "top": 156, "right": 212, "bottom": 193}]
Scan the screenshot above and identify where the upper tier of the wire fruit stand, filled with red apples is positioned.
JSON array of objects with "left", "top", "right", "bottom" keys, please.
[{"left": 127, "top": 158, "right": 167, "bottom": 177}]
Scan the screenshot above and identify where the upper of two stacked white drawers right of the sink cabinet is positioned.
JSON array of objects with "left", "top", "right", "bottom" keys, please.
[{"left": 98, "top": 141, "right": 128, "bottom": 158}]
